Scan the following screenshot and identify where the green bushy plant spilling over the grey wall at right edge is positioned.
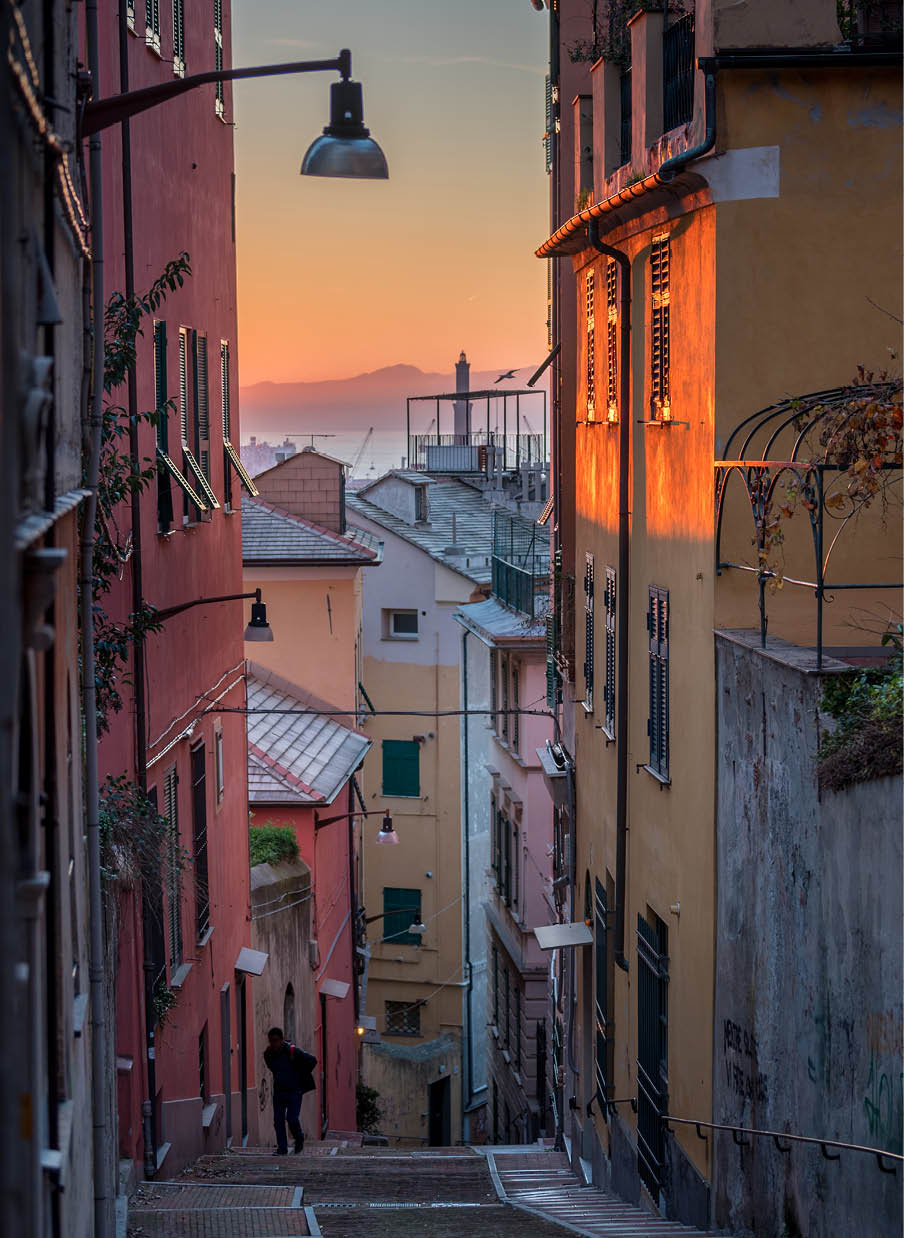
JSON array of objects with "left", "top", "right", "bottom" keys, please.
[{"left": 817, "top": 624, "right": 904, "bottom": 791}]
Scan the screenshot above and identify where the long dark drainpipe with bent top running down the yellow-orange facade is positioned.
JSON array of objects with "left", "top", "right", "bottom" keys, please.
[{"left": 587, "top": 217, "right": 626, "bottom": 972}]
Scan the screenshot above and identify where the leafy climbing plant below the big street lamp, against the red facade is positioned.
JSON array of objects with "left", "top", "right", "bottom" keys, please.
[{"left": 92, "top": 254, "right": 191, "bottom": 734}]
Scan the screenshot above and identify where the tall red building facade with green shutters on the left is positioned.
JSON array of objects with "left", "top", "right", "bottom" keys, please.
[{"left": 89, "top": 0, "right": 258, "bottom": 1176}]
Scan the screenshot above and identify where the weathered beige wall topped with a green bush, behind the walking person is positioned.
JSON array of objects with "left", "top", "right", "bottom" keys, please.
[{"left": 251, "top": 860, "right": 319, "bottom": 1143}]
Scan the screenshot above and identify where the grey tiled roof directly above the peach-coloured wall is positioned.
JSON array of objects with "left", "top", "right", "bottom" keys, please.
[{"left": 241, "top": 496, "right": 380, "bottom": 563}]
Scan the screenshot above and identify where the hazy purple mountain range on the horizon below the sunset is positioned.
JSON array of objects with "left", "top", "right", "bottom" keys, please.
[{"left": 240, "top": 363, "right": 546, "bottom": 442}]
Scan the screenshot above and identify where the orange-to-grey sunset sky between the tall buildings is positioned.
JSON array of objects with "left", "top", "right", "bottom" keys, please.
[{"left": 232, "top": 0, "right": 547, "bottom": 385}]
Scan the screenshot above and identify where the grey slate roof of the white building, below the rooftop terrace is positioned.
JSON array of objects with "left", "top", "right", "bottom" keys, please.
[{"left": 346, "top": 470, "right": 493, "bottom": 584}]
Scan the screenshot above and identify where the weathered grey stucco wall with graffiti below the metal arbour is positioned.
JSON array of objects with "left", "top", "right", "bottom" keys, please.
[{"left": 713, "top": 633, "right": 904, "bottom": 1238}]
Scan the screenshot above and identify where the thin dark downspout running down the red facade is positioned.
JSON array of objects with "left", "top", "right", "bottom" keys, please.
[{"left": 119, "top": 5, "right": 157, "bottom": 1179}]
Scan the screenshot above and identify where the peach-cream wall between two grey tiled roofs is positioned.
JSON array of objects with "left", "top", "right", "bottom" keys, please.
[{"left": 244, "top": 566, "right": 362, "bottom": 723}]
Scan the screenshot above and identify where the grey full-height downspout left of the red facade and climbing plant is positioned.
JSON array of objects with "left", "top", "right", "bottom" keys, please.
[{"left": 79, "top": 0, "right": 113, "bottom": 1238}]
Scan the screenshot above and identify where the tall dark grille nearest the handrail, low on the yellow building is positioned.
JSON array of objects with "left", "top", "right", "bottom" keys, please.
[{"left": 638, "top": 915, "right": 669, "bottom": 1200}]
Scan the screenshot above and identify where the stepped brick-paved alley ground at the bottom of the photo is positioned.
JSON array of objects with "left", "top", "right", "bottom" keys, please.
[{"left": 126, "top": 1140, "right": 706, "bottom": 1238}]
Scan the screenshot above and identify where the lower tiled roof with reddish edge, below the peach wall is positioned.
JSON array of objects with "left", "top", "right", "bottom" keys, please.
[{"left": 248, "top": 665, "right": 372, "bottom": 803}]
